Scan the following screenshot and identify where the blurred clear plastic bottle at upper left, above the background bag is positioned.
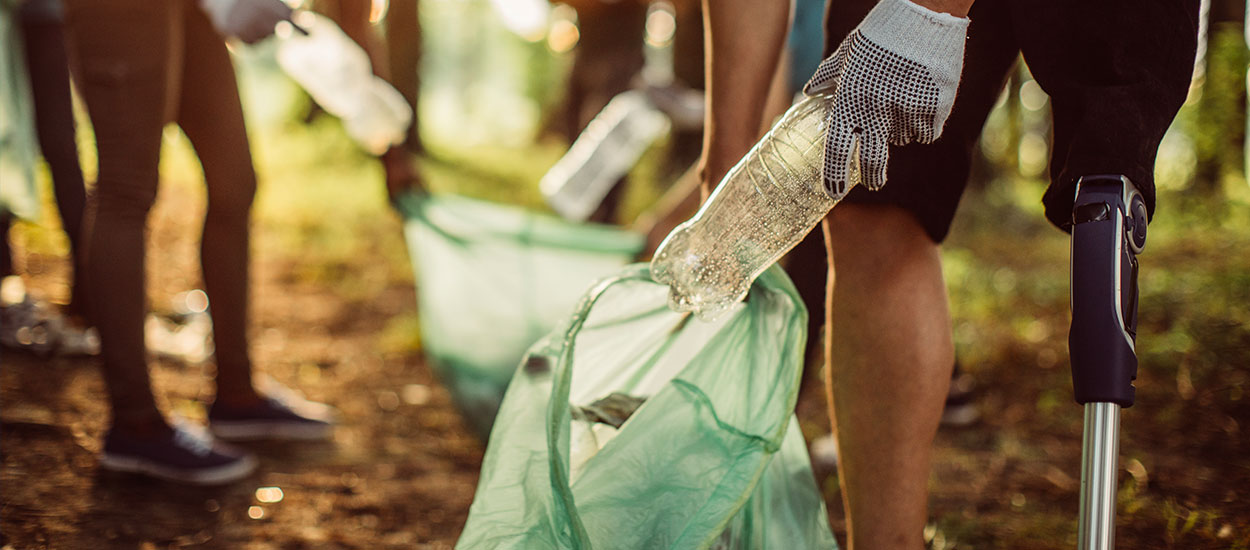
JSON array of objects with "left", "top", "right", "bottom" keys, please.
[{"left": 275, "top": 11, "right": 413, "bottom": 155}]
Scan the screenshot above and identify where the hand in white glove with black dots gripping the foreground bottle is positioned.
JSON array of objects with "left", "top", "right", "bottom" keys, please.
[{"left": 803, "top": 0, "right": 969, "bottom": 200}]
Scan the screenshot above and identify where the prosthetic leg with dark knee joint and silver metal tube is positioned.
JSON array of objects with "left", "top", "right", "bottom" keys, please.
[{"left": 1068, "top": 175, "right": 1148, "bottom": 550}]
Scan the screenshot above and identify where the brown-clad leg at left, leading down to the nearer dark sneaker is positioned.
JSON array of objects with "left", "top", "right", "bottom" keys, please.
[{"left": 65, "top": 0, "right": 184, "bottom": 436}]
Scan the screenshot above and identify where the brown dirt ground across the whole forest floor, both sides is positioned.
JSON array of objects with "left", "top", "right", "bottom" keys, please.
[{"left": 0, "top": 172, "right": 1250, "bottom": 550}]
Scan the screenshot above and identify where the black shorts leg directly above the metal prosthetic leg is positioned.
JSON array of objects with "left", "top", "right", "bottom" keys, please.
[{"left": 1011, "top": 0, "right": 1199, "bottom": 228}]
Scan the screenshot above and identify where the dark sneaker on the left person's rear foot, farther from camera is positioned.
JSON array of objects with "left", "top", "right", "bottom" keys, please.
[{"left": 209, "top": 386, "right": 334, "bottom": 441}]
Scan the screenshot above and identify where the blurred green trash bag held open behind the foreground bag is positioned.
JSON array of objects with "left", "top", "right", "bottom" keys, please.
[{"left": 401, "top": 194, "right": 644, "bottom": 438}]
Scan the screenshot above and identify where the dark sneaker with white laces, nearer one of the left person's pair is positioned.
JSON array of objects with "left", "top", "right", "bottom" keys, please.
[{"left": 100, "top": 425, "right": 256, "bottom": 485}]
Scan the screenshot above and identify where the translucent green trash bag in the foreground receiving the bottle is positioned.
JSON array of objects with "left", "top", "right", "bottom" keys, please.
[{"left": 456, "top": 265, "right": 836, "bottom": 550}]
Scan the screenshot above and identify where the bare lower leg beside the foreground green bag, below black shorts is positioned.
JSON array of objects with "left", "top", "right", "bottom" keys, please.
[{"left": 824, "top": 204, "right": 954, "bottom": 550}]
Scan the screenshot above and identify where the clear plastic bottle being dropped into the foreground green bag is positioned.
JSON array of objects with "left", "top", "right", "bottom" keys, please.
[{"left": 651, "top": 95, "right": 859, "bottom": 320}]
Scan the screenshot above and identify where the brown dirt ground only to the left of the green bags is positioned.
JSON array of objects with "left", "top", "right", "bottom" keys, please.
[{"left": 0, "top": 180, "right": 484, "bottom": 549}]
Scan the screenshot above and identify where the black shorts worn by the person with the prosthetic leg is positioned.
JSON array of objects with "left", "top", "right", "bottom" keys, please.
[{"left": 825, "top": 0, "right": 1199, "bottom": 243}]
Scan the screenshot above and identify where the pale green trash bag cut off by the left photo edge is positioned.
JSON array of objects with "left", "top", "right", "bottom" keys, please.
[{"left": 0, "top": 0, "right": 39, "bottom": 221}]
